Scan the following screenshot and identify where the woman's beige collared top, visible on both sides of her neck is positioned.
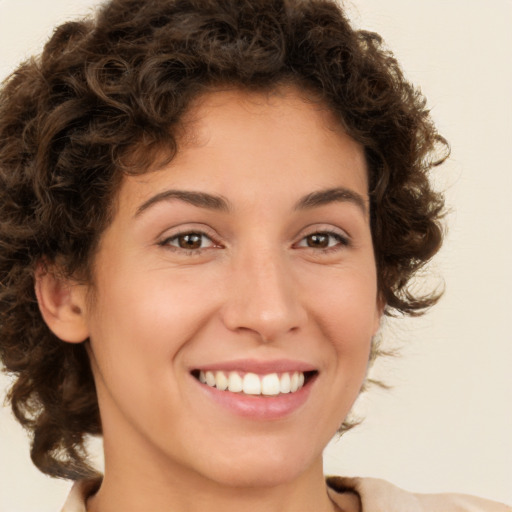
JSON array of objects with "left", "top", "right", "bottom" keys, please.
[{"left": 61, "top": 476, "right": 512, "bottom": 512}]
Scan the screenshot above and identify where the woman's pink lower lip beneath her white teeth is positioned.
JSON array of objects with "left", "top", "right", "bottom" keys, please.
[{"left": 192, "top": 376, "right": 316, "bottom": 421}]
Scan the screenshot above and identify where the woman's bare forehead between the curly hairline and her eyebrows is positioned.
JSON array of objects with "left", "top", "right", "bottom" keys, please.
[{"left": 115, "top": 87, "right": 367, "bottom": 215}]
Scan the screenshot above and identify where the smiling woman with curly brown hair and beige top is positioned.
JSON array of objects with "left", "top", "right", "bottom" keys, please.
[{"left": 0, "top": 0, "right": 507, "bottom": 512}]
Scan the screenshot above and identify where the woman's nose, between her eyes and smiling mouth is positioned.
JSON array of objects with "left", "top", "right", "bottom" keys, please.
[{"left": 222, "top": 246, "right": 307, "bottom": 342}]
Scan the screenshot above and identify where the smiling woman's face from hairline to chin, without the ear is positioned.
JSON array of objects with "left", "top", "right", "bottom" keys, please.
[{"left": 85, "top": 89, "right": 381, "bottom": 486}]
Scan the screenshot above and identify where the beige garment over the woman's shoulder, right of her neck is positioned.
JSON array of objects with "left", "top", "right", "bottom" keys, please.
[{"left": 327, "top": 477, "right": 512, "bottom": 512}]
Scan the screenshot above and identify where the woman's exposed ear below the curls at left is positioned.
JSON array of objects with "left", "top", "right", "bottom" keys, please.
[{"left": 35, "top": 265, "right": 89, "bottom": 343}]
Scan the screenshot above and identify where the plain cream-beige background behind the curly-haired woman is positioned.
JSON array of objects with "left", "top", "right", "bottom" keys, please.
[{"left": 0, "top": 0, "right": 512, "bottom": 512}]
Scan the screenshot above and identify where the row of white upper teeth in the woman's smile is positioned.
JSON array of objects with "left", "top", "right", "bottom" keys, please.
[{"left": 199, "top": 370, "right": 304, "bottom": 396}]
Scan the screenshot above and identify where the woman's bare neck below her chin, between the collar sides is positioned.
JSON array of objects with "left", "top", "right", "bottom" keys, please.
[{"left": 88, "top": 436, "right": 339, "bottom": 512}]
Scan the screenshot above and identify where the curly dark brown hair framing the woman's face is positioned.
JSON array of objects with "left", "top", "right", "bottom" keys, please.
[{"left": 0, "top": 0, "right": 447, "bottom": 479}]
